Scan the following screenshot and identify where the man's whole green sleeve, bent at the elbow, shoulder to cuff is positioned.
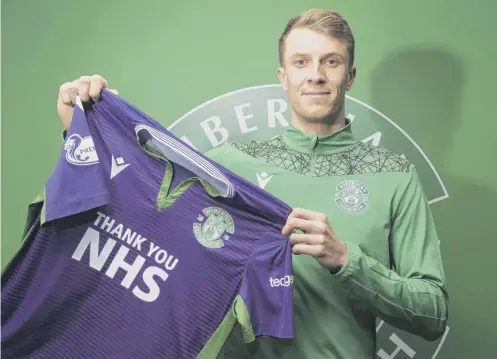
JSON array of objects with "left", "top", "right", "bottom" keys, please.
[{"left": 332, "top": 167, "right": 448, "bottom": 340}]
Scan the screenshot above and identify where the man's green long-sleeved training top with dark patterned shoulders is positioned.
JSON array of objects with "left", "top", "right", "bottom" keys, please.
[{"left": 206, "top": 122, "right": 448, "bottom": 359}]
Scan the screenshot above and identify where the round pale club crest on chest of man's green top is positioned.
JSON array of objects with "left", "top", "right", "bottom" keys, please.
[{"left": 335, "top": 180, "right": 369, "bottom": 213}]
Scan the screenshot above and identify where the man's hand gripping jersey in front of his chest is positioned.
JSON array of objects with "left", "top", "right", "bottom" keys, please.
[{"left": 282, "top": 208, "right": 347, "bottom": 272}]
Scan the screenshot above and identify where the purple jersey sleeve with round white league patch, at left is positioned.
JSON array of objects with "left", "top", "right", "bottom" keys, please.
[{"left": 41, "top": 102, "right": 109, "bottom": 224}]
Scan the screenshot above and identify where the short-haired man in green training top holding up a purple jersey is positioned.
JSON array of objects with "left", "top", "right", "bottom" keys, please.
[{"left": 53, "top": 9, "right": 448, "bottom": 359}]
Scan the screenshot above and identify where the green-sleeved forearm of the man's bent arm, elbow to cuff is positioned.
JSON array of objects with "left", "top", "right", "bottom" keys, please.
[{"left": 332, "top": 243, "right": 448, "bottom": 340}]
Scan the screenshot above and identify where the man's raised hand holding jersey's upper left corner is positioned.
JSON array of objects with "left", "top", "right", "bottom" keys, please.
[{"left": 57, "top": 75, "right": 119, "bottom": 130}]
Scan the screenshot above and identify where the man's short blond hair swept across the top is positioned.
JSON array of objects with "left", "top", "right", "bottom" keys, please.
[{"left": 279, "top": 9, "right": 355, "bottom": 68}]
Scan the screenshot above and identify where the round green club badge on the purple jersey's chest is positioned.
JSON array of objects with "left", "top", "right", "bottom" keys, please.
[{"left": 193, "top": 207, "right": 235, "bottom": 248}]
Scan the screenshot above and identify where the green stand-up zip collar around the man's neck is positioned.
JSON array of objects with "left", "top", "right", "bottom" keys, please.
[{"left": 282, "top": 120, "right": 357, "bottom": 155}]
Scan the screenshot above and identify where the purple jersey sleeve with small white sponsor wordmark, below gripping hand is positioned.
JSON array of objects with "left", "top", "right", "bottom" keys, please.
[{"left": 235, "top": 229, "right": 294, "bottom": 343}]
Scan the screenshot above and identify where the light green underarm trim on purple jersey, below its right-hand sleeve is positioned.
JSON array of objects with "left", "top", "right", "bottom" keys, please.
[{"left": 197, "top": 295, "right": 255, "bottom": 359}]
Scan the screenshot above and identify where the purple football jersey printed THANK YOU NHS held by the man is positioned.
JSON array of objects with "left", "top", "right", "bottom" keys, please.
[{"left": 2, "top": 90, "right": 294, "bottom": 359}]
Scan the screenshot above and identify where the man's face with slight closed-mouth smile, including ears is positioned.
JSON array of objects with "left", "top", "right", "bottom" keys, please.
[{"left": 278, "top": 28, "right": 355, "bottom": 122}]
